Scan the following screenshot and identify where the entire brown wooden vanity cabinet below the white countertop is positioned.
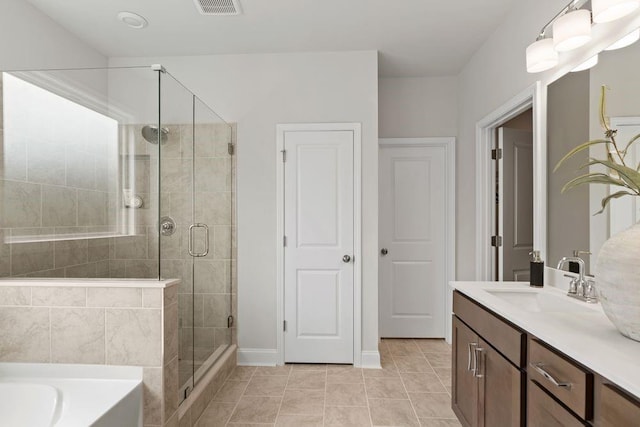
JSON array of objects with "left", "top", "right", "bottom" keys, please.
[{"left": 451, "top": 291, "right": 640, "bottom": 427}]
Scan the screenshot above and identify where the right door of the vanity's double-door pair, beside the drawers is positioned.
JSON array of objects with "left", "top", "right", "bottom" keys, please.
[{"left": 477, "top": 339, "right": 525, "bottom": 427}]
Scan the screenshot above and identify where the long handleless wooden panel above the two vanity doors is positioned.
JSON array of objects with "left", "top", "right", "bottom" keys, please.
[{"left": 453, "top": 291, "right": 526, "bottom": 368}]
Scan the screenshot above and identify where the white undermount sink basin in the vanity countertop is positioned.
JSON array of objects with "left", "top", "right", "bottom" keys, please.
[{"left": 487, "top": 289, "right": 593, "bottom": 313}]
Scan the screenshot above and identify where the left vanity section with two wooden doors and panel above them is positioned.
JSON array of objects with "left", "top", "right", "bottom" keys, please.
[{"left": 452, "top": 293, "right": 525, "bottom": 427}]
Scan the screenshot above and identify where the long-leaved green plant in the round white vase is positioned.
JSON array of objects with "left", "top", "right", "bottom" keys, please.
[{"left": 553, "top": 86, "right": 640, "bottom": 215}]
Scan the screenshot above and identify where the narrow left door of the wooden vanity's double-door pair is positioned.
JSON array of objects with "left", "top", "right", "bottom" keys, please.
[{"left": 451, "top": 316, "right": 478, "bottom": 427}]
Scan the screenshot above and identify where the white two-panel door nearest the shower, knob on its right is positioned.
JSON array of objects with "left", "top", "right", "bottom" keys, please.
[{"left": 284, "top": 131, "right": 360, "bottom": 363}]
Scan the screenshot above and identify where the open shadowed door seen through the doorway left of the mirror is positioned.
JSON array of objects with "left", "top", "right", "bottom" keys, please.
[{"left": 498, "top": 128, "right": 533, "bottom": 282}]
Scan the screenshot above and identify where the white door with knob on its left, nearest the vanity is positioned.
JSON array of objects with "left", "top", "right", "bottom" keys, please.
[{"left": 378, "top": 146, "right": 447, "bottom": 338}]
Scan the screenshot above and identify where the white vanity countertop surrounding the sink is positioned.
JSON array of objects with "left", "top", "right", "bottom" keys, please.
[{"left": 449, "top": 282, "right": 640, "bottom": 398}]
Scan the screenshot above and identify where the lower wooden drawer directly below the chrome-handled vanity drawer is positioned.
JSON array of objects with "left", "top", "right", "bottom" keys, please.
[{"left": 527, "top": 381, "right": 586, "bottom": 427}]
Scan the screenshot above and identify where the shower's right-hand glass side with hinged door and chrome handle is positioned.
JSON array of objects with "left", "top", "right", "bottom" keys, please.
[{"left": 158, "top": 73, "right": 232, "bottom": 397}]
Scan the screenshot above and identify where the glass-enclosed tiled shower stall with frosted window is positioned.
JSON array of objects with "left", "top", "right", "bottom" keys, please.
[{"left": 0, "top": 65, "right": 236, "bottom": 399}]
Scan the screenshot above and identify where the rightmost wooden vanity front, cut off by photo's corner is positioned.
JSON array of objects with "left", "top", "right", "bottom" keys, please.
[{"left": 596, "top": 384, "right": 640, "bottom": 427}]
